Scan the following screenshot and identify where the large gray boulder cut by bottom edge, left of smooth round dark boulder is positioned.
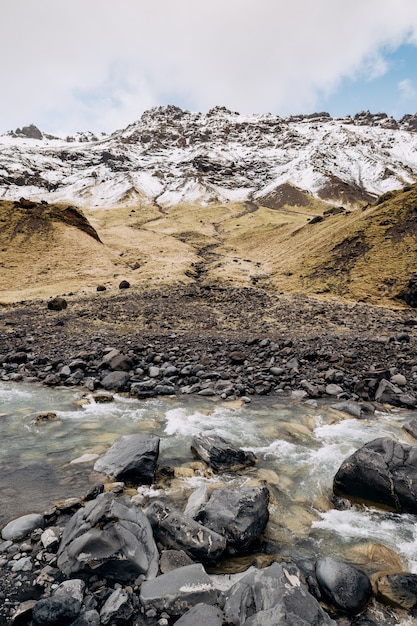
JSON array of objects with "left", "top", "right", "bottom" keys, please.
[{"left": 223, "top": 563, "right": 336, "bottom": 626}]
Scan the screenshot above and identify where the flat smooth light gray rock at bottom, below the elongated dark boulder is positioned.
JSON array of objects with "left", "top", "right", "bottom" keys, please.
[{"left": 140, "top": 564, "right": 218, "bottom": 615}]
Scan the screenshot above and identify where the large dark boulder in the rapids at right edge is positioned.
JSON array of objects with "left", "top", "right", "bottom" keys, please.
[{"left": 333, "top": 437, "right": 417, "bottom": 513}]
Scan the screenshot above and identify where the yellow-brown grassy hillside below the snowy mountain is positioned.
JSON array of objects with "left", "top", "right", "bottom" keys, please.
[{"left": 0, "top": 185, "right": 417, "bottom": 306}]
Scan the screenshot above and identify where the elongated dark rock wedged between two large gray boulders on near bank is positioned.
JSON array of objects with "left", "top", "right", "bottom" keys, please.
[{"left": 146, "top": 501, "right": 226, "bottom": 561}]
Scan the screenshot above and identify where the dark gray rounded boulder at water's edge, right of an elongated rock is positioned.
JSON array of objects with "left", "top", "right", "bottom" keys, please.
[{"left": 197, "top": 487, "right": 269, "bottom": 551}]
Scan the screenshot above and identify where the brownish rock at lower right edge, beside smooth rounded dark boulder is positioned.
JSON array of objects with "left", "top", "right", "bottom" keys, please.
[{"left": 373, "top": 573, "right": 417, "bottom": 610}]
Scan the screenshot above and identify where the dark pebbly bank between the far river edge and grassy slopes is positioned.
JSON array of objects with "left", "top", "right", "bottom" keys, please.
[{"left": 0, "top": 285, "right": 417, "bottom": 407}]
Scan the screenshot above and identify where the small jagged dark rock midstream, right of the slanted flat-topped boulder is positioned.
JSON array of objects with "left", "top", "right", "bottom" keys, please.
[{"left": 191, "top": 433, "right": 256, "bottom": 472}]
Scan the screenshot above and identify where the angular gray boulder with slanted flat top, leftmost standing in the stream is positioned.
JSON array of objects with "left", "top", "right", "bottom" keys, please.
[{"left": 94, "top": 434, "right": 160, "bottom": 485}]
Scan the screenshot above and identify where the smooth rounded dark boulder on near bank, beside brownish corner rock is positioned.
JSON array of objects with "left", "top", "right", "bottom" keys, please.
[{"left": 316, "top": 557, "right": 372, "bottom": 615}]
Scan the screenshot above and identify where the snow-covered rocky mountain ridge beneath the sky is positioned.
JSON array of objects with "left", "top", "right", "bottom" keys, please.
[{"left": 0, "top": 106, "right": 417, "bottom": 207}]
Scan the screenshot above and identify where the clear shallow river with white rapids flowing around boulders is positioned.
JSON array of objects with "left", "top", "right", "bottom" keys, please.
[{"left": 0, "top": 376, "right": 417, "bottom": 573}]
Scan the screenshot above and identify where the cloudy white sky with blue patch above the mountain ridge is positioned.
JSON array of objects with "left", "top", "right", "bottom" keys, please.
[{"left": 0, "top": 0, "right": 417, "bottom": 133}]
